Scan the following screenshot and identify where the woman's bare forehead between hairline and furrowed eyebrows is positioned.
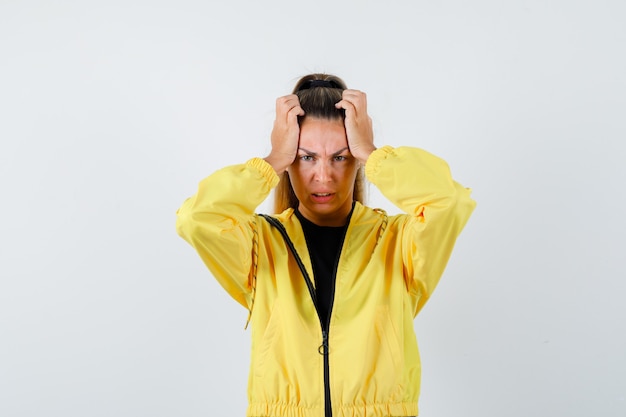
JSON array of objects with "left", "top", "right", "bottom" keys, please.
[{"left": 299, "top": 117, "right": 348, "bottom": 153}]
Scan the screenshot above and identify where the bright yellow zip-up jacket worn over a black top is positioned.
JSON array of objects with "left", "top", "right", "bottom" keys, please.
[{"left": 176, "top": 146, "right": 475, "bottom": 417}]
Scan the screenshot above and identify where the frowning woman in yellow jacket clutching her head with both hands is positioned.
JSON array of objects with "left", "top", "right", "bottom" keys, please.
[{"left": 177, "top": 74, "right": 475, "bottom": 417}]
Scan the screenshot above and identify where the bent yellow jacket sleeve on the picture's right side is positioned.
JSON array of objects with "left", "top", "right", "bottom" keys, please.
[{"left": 365, "top": 146, "right": 476, "bottom": 314}]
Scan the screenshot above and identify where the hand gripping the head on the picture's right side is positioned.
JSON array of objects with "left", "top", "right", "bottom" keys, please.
[{"left": 335, "top": 90, "right": 376, "bottom": 164}]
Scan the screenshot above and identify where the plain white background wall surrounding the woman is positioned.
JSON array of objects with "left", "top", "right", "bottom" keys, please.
[{"left": 0, "top": 0, "right": 626, "bottom": 417}]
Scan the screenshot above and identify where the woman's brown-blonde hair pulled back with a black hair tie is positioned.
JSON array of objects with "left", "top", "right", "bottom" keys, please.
[{"left": 274, "top": 74, "right": 365, "bottom": 213}]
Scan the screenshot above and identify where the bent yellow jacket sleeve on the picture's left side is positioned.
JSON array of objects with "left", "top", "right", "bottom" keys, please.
[{"left": 176, "top": 158, "right": 279, "bottom": 308}]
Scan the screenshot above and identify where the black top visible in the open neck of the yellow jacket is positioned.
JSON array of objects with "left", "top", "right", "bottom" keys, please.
[{"left": 295, "top": 210, "right": 348, "bottom": 327}]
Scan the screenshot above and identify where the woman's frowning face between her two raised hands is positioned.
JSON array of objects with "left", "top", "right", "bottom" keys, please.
[{"left": 288, "top": 117, "right": 359, "bottom": 226}]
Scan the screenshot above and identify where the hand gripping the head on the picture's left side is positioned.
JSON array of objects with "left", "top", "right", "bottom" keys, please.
[{"left": 265, "top": 94, "right": 304, "bottom": 175}]
